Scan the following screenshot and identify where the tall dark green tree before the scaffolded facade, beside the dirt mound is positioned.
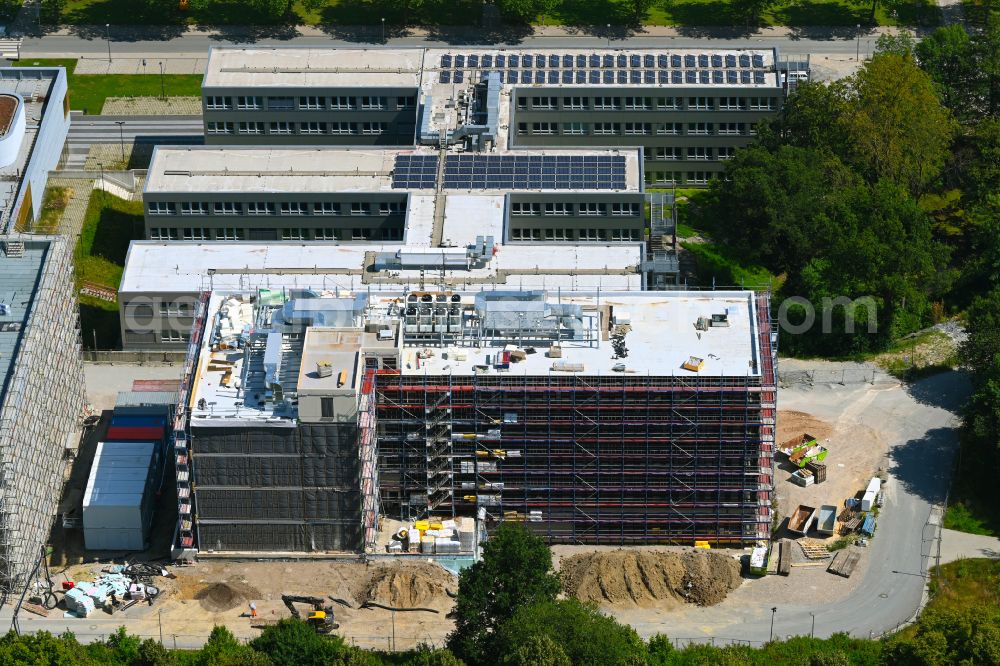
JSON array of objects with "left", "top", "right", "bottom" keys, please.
[{"left": 448, "top": 523, "right": 560, "bottom": 664}]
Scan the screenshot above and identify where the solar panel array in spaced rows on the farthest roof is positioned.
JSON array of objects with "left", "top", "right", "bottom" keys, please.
[{"left": 438, "top": 53, "right": 770, "bottom": 85}]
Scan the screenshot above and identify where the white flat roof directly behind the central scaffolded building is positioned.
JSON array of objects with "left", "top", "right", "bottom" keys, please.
[{"left": 119, "top": 237, "right": 643, "bottom": 294}]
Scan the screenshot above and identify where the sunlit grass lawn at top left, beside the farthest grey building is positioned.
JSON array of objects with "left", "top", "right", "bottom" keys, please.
[{"left": 13, "top": 58, "right": 202, "bottom": 114}]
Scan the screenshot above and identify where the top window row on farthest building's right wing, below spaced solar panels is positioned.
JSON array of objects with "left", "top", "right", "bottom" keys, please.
[{"left": 517, "top": 95, "right": 778, "bottom": 111}]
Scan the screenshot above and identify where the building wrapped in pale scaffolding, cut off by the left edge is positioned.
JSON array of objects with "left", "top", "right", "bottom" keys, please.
[{"left": 0, "top": 236, "right": 84, "bottom": 594}]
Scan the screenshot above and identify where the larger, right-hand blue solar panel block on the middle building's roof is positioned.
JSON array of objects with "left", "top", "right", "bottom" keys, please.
[{"left": 444, "top": 155, "right": 625, "bottom": 190}]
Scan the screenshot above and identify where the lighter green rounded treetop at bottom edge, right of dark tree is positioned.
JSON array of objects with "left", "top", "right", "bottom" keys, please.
[{"left": 497, "top": 599, "right": 646, "bottom": 666}]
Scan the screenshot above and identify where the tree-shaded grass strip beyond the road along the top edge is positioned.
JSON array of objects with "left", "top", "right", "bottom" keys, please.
[{"left": 52, "top": 0, "right": 940, "bottom": 27}]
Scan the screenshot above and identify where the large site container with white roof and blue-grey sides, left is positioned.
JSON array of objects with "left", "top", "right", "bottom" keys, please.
[{"left": 83, "top": 442, "right": 160, "bottom": 550}]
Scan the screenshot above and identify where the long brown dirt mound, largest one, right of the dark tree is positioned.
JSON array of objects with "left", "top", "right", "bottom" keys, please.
[{"left": 560, "top": 550, "right": 742, "bottom": 606}]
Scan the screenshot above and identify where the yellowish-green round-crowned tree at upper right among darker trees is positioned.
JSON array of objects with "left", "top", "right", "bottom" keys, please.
[{"left": 843, "top": 54, "right": 953, "bottom": 192}]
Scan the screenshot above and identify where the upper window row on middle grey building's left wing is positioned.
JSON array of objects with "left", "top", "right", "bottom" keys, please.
[{"left": 146, "top": 201, "right": 406, "bottom": 216}]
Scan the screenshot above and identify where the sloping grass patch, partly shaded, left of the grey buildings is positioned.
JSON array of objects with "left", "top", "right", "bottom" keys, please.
[{"left": 74, "top": 190, "right": 143, "bottom": 349}]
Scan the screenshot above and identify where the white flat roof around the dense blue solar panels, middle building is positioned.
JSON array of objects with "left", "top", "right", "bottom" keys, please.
[{"left": 144, "top": 146, "right": 643, "bottom": 195}]
